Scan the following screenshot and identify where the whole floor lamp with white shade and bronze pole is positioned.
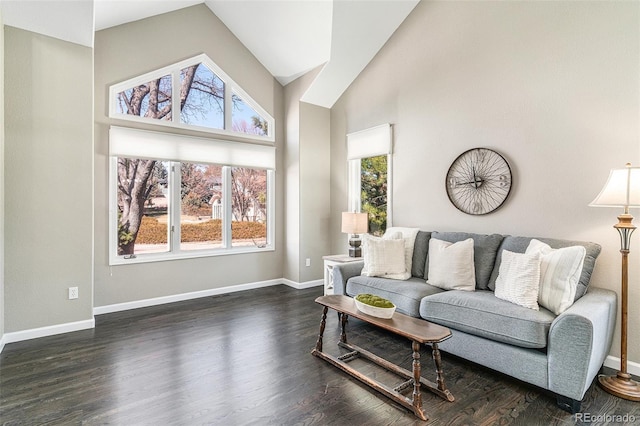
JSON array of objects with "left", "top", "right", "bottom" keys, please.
[{"left": 590, "top": 163, "right": 640, "bottom": 401}]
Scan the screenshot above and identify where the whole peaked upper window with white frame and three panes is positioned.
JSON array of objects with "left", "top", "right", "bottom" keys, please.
[{"left": 110, "top": 54, "right": 275, "bottom": 141}]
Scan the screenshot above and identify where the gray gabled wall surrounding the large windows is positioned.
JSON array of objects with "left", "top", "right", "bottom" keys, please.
[{"left": 94, "top": 4, "right": 284, "bottom": 307}]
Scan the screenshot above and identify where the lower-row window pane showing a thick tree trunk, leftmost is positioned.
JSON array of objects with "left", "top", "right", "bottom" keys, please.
[{"left": 117, "top": 158, "right": 169, "bottom": 256}]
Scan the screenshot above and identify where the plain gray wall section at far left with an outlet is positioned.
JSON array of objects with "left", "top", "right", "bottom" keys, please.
[{"left": 4, "top": 27, "right": 93, "bottom": 333}]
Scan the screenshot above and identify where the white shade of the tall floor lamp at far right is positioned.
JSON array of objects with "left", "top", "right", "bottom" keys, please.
[{"left": 589, "top": 163, "right": 640, "bottom": 207}]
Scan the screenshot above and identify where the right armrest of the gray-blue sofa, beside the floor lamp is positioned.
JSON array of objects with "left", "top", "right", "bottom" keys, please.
[{"left": 547, "top": 287, "right": 618, "bottom": 401}]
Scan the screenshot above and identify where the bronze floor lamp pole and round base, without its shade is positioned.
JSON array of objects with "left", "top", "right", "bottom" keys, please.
[{"left": 598, "top": 212, "right": 640, "bottom": 401}]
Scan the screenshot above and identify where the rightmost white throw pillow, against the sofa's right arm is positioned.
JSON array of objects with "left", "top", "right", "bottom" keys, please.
[{"left": 526, "top": 239, "right": 587, "bottom": 315}]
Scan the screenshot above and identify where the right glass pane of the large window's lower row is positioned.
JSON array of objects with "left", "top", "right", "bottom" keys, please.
[{"left": 231, "top": 167, "right": 267, "bottom": 247}]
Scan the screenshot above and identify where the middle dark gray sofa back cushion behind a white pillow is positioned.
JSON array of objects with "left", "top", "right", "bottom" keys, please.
[{"left": 425, "top": 232, "right": 504, "bottom": 290}]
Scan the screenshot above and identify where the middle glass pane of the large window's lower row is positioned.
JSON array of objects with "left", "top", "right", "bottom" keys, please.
[{"left": 180, "top": 163, "right": 223, "bottom": 250}]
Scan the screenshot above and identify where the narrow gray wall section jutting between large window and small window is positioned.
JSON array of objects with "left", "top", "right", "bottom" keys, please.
[{"left": 283, "top": 67, "right": 331, "bottom": 283}]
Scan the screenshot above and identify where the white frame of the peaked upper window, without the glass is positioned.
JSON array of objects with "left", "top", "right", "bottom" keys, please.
[{"left": 109, "top": 53, "right": 275, "bottom": 142}]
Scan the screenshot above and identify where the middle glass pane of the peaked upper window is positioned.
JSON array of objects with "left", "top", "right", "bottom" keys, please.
[{"left": 180, "top": 64, "right": 224, "bottom": 129}]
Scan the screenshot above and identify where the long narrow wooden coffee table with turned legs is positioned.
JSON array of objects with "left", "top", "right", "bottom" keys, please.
[{"left": 311, "top": 295, "right": 454, "bottom": 420}]
